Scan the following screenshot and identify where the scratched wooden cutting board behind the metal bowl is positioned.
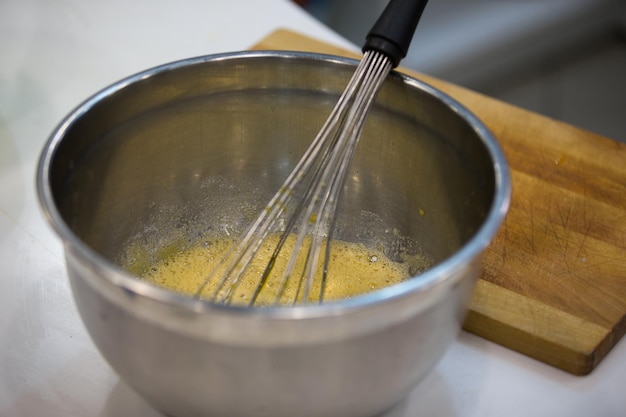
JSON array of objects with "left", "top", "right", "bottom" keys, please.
[{"left": 254, "top": 30, "right": 626, "bottom": 375}]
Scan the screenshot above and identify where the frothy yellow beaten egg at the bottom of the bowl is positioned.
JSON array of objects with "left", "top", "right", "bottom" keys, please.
[{"left": 142, "top": 235, "right": 426, "bottom": 306}]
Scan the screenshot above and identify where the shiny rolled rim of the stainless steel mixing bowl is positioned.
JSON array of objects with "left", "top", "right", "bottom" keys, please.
[{"left": 36, "top": 51, "right": 511, "bottom": 319}]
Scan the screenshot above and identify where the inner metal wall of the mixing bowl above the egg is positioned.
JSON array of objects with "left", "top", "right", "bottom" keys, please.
[{"left": 50, "top": 54, "right": 496, "bottom": 296}]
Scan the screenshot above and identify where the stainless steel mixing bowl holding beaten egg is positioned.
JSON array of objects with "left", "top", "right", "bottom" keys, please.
[{"left": 37, "top": 52, "right": 510, "bottom": 417}]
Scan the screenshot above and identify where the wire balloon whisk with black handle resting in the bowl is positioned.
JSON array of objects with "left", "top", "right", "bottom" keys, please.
[{"left": 196, "top": 0, "right": 427, "bottom": 306}]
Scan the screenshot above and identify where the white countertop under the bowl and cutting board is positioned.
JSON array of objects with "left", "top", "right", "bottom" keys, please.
[{"left": 0, "top": 0, "right": 626, "bottom": 417}]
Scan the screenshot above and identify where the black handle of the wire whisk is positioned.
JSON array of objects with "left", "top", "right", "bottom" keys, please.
[{"left": 363, "top": 0, "right": 428, "bottom": 67}]
